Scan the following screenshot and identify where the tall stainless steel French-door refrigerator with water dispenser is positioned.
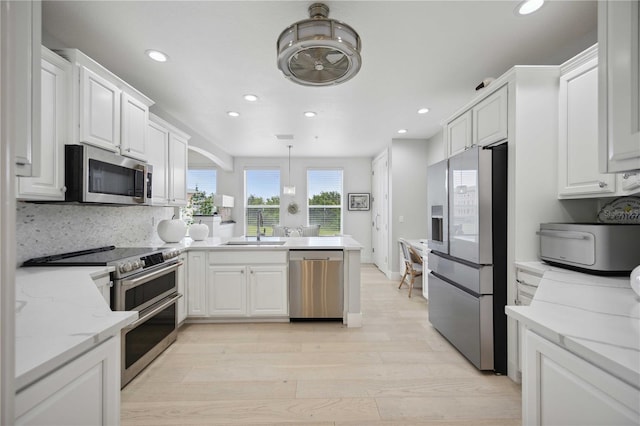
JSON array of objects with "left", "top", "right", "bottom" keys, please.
[{"left": 427, "top": 143, "right": 507, "bottom": 374}]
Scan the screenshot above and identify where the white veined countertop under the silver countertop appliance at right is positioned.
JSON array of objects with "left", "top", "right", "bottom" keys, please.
[{"left": 505, "top": 267, "right": 640, "bottom": 389}]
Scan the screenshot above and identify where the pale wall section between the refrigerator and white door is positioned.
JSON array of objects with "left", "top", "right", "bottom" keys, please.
[{"left": 389, "top": 139, "right": 430, "bottom": 274}]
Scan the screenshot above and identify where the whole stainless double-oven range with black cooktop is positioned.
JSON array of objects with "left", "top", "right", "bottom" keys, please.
[{"left": 23, "top": 246, "right": 182, "bottom": 387}]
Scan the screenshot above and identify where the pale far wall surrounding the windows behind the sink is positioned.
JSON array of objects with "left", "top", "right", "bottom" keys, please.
[{"left": 216, "top": 156, "right": 371, "bottom": 263}]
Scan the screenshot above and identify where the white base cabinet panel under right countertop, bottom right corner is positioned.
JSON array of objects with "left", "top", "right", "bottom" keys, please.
[{"left": 522, "top": 329, "right": 640, "bottom": 426}]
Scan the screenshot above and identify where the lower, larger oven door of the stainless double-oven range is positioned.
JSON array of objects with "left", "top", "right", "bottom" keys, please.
[{"left": 120, "top": 293, "right": 182, "bottom": 387}]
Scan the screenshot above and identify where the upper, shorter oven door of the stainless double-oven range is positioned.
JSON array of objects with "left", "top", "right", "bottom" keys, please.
[{"left": 113, "top": 262, "right": 182, "bottom": 311}]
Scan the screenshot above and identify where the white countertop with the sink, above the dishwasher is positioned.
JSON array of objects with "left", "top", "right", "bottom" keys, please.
[{"left": 165, "top": 236, "right": 362, "bottom": 250}]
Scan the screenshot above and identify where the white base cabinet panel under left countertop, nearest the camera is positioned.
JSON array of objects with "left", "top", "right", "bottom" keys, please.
[{"left": 15, "top": 334, "right": 120, "bottom": 425}]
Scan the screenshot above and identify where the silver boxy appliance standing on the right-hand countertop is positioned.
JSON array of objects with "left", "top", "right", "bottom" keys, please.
[{"left": 538, "top": 223, "right": 640, "bottom": 275}]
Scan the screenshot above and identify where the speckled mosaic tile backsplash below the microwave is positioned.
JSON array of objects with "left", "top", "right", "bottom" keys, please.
[{"left": 16, "top": 202, "right": 174, "bottom": 264}]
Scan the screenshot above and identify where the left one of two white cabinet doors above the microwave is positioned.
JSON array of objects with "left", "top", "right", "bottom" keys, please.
[{"left": 79, "top": 67, "right": 120, "bottom": 152}]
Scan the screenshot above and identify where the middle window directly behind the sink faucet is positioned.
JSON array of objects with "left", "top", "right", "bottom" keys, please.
[{"left": 244, "top": 170, "right": 280, "bottom": 236}]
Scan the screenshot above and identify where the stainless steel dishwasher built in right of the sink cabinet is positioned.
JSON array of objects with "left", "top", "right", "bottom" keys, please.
[{"left": 289, "top": 250, "right": 344, "bottom": 320}]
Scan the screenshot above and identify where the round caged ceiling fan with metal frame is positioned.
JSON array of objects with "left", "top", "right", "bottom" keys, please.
[{"left": 277, "top": 3, "right": 362, "bottom": 86}]
